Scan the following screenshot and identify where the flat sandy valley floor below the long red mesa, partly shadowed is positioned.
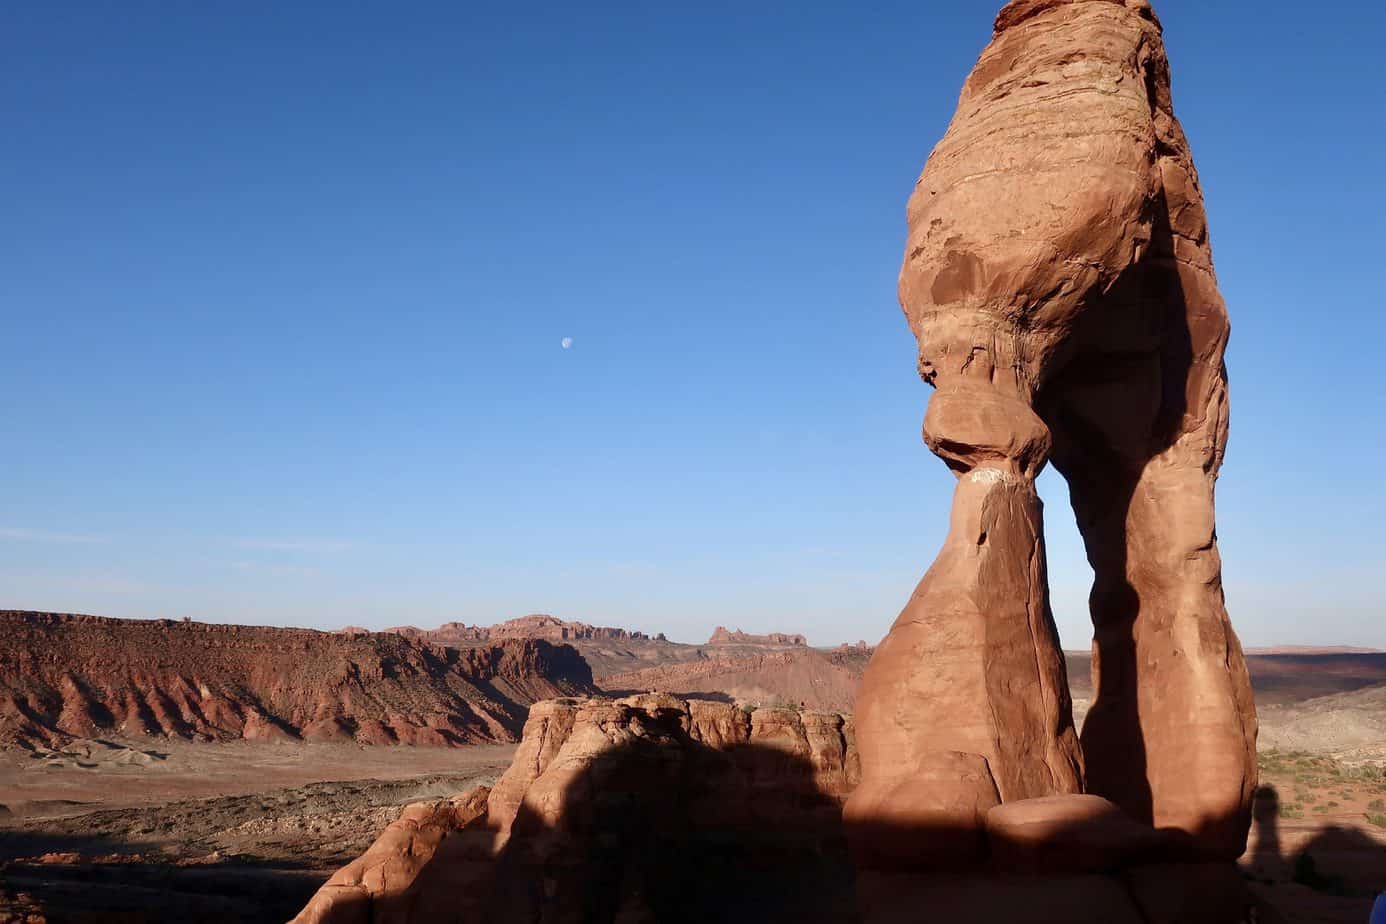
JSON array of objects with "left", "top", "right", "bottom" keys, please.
[{"left": 0, "top": 740, "right": 514, "bottom": 924}]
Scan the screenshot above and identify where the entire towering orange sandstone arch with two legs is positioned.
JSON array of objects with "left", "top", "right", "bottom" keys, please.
[{"left": 845, "top": 0, "right": 1256, "bottom": 921}]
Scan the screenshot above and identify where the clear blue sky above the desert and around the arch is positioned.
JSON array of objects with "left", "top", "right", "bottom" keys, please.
[{"left": 0, "top": 0, "right": 1386, "bottom": 647}]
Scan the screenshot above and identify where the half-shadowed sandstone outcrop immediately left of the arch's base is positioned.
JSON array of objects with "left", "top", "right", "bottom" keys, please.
[{"left": 294, "top": 694, "right": 858, "bottom": 924}]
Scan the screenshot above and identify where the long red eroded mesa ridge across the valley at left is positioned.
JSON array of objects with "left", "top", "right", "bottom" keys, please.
[{"left": 0, "top": 611, "right": 595, "bottom": 745}]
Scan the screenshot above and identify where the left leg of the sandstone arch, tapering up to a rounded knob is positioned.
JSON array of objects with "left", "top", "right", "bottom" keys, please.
[{"left": 847, "top": 371, "right": 1082, "bottom": 866}]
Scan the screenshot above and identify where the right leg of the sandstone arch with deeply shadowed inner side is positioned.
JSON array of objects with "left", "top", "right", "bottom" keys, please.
[{"left": 1040, "top": 195, "right": 1256, "bottom": 859}]
